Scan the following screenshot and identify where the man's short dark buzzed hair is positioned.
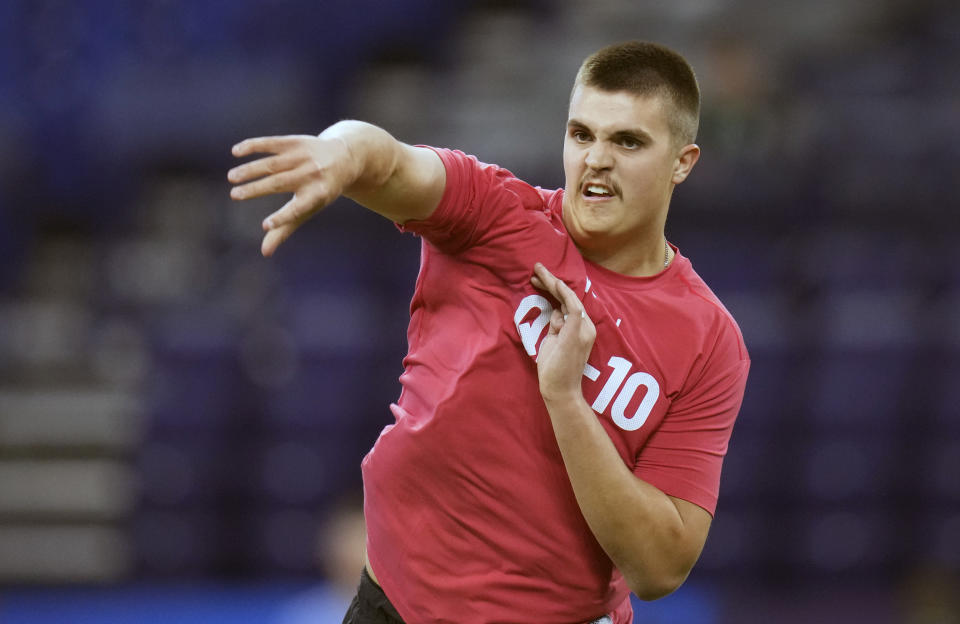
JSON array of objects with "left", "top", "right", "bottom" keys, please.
[{"left": 574, "top": 41, "right": 700, "bottom": 145}]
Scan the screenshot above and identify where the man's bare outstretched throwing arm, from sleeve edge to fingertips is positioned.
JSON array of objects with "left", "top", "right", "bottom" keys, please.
[{"left": 227, "top": 121, "right": 446, "bottom": 256}]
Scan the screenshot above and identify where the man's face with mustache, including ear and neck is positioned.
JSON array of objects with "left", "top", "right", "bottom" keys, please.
[{"left": 563, "top": 85, "right": 700, "bottom": 268}]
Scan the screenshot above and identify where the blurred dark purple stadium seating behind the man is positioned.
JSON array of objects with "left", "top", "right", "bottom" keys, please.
[{"left": 0, "top": 0, "right": 960, "bottom": 624}]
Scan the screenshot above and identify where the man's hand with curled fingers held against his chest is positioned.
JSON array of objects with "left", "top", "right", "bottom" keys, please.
[{"left": 530, "top": 262, "right": 597, "bottom": 401}]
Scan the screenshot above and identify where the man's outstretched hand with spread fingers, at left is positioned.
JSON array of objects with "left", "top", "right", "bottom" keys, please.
[{"left": 227, "top": 135, "right": 356, "bottom": 257}]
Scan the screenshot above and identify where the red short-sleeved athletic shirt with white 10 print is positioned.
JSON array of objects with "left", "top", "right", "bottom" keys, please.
[{"left": 363, "top": 150, "right": 749, "bottom": 624}]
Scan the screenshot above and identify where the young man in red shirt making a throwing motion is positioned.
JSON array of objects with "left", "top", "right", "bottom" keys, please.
[{"left": 229, "top": 42, "right": 749, "bottom": 624}]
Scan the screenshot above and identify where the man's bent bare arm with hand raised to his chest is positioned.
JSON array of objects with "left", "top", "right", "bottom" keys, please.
[{"left": 531, "top": 263, "right": 712, "bottom": 600}]
